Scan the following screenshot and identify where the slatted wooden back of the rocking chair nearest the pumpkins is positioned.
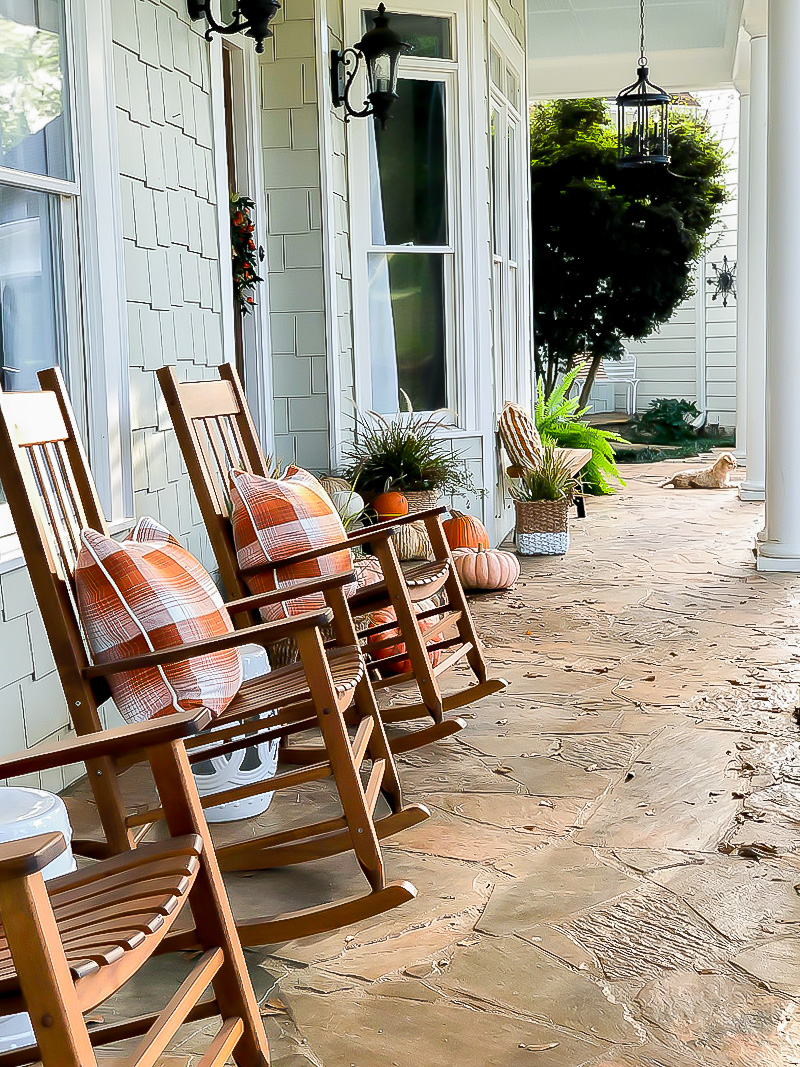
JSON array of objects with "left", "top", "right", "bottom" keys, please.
[{"left": 157, "top": 364, "right": 270, "bottom": 614}]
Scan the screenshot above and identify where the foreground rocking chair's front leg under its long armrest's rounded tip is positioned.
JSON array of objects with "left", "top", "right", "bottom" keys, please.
[{"left": 149, "top": 745, "right": 270, "bottom": 1067}]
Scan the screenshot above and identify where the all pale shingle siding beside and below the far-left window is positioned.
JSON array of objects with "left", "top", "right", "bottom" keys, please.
[{"left": 0, "top": 0, "right": 227, "bottom": 772}]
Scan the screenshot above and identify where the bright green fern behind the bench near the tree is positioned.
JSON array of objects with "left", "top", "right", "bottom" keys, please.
[{"left": 534, "top": 364, "right": 625, "bottom": 496}]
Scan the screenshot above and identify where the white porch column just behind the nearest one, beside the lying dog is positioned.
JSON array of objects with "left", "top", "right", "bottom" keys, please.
[{"left": 739, "top": 36, "right": 769, "bottom": 500}]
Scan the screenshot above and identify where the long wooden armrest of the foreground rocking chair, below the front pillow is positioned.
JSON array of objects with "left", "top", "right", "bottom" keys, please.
[{"left": 0, "top": 707, "right": 211, "bottom": 778}]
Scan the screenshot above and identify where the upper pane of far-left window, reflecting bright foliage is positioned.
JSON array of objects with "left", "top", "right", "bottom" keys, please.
[{"left": 0, "top": 0, "right": 73, "bottom": 178}]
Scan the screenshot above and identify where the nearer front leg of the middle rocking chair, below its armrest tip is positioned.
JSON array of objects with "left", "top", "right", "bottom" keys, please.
[{"left": 295, "top": 630, "right": 385, "bottom": 892}]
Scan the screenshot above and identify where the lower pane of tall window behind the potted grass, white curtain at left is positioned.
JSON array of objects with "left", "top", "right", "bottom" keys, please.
[{"left": 369, "top": 253, "right": 446, "bottom": 415}]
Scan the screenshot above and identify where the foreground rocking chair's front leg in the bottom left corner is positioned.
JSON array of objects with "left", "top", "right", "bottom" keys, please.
[{"left": 0, "top": 874, "right": 97, "bottom": 1067}]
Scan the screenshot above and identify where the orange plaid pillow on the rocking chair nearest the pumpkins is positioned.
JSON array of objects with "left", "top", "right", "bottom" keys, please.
[{"left": 230, "top": 467, "right": 356, "bottom": 621}]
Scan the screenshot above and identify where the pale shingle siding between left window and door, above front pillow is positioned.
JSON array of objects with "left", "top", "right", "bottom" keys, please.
[{"left": 113, "top": 0, "right": 222, "bottom": 564}]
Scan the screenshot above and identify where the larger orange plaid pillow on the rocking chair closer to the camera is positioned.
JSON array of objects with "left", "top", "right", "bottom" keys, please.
[{"left": 75, "top": 519, "right": 243, "bottom": 722}]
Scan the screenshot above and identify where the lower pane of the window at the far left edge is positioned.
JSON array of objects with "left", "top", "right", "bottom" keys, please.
[{"left": 0, "top": 186, "right": 65, "bottom": 389}]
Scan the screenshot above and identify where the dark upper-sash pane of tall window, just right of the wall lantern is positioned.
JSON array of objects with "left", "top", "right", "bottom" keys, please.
[{"left": 370, "top": 79, "right": 448, "bottom": 244}]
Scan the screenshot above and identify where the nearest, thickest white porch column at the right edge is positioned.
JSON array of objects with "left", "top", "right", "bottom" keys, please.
[{"left": 751, "top": 0, "right": 800, "bottom": 572}]
